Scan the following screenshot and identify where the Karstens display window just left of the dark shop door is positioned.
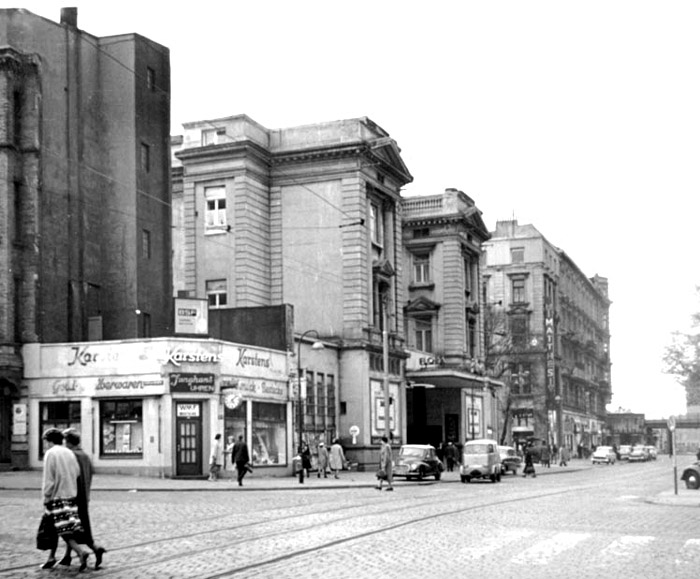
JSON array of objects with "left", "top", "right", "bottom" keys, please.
[{"left": 100, "top": 399, "right": 143, "bottom": 458}]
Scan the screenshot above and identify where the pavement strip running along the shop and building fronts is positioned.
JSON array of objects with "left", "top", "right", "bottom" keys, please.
[{"left": 0, "top": 461, "right": 592, "bottom": 499}]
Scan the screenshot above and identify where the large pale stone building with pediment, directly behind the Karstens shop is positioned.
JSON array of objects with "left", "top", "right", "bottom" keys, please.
[{"left": 173, "top": 115, "right": 412, "bottom": 463}]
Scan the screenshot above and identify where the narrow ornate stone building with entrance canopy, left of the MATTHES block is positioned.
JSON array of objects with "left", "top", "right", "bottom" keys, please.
[{"left": 401, "top": 189, "right": 500, "bottom": 447}]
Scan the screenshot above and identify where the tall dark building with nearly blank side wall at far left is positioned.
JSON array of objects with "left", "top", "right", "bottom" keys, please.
[{"left": 0, "top": 8, "right": 172, "bottom": 466}]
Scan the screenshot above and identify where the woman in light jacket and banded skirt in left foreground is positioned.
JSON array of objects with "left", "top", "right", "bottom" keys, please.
[{"left": 41, "top": 428, "right": 90, "bottom": 571}]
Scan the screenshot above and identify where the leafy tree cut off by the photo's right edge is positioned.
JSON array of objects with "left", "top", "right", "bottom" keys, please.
[{"left": 663, "top": 287, "right": 700, "bottom": 406}]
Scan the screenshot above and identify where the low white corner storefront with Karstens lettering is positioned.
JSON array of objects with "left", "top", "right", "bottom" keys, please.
[{"left": 23, "top": 338, "right": 292, "bottom": 477}]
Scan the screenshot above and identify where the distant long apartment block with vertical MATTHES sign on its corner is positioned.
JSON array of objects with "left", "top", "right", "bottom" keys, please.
[{"left": 482, "top": 220, "right": 611, "bottom": 450}]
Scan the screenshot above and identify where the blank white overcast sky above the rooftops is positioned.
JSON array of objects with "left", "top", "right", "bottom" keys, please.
[{"left": 12, "top": 0, "right": 700, "bottom": 418}]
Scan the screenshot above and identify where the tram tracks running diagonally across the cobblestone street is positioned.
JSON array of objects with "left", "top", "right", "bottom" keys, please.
[{"left": 0, "top": 469, "right": 668, "bottom": 579}]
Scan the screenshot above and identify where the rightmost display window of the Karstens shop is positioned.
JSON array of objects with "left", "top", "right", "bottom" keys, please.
[{"left": 252, "top": 402, "right": 287, "bottom": 466}]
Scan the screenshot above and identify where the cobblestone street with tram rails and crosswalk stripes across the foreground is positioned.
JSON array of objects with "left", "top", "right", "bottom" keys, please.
[{"left": 0, "top": 456, "right": 700, "bottom": 579}]
